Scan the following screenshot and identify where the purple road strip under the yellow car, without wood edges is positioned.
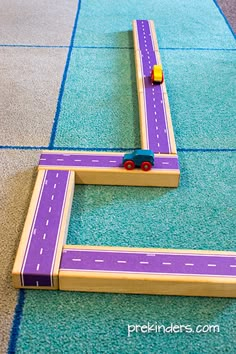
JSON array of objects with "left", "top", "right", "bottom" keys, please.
[{"left": 136, "top": 20, "right": 172, "bottom": 154}]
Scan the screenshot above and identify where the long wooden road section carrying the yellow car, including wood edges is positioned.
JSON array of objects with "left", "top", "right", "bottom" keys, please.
[{"left": 133, "top": 20, "right": 176, "bottom": 154}]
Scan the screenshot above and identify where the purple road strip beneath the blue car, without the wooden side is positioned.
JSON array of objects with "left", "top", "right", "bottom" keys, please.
[{"left": 39, "top": 153, "right": 179, "bottom": 173}]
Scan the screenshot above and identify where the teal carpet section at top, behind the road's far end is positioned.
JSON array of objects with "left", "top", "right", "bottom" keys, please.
[{"left": 75, "top": 0, "right": 235, "bottom": 48}]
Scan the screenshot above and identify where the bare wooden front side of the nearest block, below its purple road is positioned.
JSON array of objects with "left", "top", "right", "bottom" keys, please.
[{"left": 59, "top": 270, "right": 236, "bottom": 297}]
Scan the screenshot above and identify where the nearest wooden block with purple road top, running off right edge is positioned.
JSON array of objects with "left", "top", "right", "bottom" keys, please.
[{"left": 59, "top": 245, "right": 236, "bottom": 297}]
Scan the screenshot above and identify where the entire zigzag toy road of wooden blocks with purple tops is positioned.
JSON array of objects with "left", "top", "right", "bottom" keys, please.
[{"left": 12, "top": 20, "right": 236, "bottom": 297}]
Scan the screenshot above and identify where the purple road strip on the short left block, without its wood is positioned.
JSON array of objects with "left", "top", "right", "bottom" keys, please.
[{"left": 21, "top": 171, "right": 70, "bottom": 286}]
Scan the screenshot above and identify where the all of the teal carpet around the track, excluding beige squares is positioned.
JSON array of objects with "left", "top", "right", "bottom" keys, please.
[{"left": 9, "top": 0, "right": 236, "bottom": 354}]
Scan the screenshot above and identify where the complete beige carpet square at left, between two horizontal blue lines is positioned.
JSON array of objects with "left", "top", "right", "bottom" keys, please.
[{"left": 0, "top": 47, "right": 67, "bottom": 147}]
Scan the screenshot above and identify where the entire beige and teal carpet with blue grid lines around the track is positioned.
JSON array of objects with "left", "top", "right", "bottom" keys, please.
[{"left": 0, "top": 0, "right": 236, "bottom": 354}]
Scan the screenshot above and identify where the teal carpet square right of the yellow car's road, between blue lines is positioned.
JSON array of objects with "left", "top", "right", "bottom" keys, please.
[{"left": 161, "top": 51, "right": 236, "bottom": 149}]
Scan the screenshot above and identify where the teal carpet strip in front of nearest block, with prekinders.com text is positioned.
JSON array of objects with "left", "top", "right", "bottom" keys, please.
[{"left": 15, "top": 291, "right": 236, "bottom": 354}]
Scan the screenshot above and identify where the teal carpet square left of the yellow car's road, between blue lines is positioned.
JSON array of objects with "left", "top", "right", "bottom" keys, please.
[{"left": 55, "top": 49, "right": 140, "bottom": 149}]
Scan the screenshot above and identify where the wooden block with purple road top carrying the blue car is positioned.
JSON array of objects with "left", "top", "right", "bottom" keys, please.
[{"left": 39, "top": 151, "right": 180, "bottom": 187}]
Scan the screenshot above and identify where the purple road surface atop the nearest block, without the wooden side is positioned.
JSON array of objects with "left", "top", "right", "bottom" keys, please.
[{"left": 60, "top": 249, "right": 236, "bottom": 277}]
